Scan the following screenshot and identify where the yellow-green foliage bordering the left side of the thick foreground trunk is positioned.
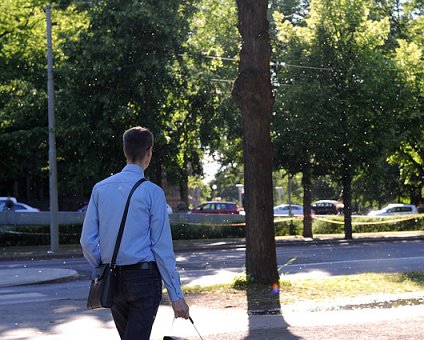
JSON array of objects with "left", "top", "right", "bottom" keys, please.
[{"left": 183, "top": 0, "right": 242, "bottom": 182}]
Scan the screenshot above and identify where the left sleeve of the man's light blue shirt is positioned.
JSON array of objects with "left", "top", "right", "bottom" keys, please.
[{"left": 80, "top": 189, "right": 101, "bottom": 268}]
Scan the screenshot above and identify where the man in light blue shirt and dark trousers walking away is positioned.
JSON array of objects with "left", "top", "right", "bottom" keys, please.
[{"left": 80, "top": 126, "right": 190, "bottom": 340}]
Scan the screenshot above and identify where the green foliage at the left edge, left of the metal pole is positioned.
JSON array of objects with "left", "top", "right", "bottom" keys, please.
[{"left": 0, "top": 1, "right": 47, "bottom": 181}]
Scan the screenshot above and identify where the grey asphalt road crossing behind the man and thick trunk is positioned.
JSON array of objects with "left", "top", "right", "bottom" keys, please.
[{"left": 0, "top": 240, "right": 424, "bottom": 285}]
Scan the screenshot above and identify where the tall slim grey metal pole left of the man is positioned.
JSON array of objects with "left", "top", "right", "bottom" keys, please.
[{"left": 46, "top": 5, "right": 59, "bottom": 253}]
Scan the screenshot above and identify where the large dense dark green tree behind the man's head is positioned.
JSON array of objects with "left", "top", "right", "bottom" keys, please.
[{"left": 57, "top": 0, "right": 195, "bottom": 202}]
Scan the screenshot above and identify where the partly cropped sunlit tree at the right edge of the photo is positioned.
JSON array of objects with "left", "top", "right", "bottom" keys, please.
[{"left": 389, "top": 1, "right": 424, "bottom": 205}]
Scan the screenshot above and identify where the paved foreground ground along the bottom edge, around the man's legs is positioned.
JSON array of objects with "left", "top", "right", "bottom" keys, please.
[{"left": 0, "top": 290, "right": 424, "bottom": 340}]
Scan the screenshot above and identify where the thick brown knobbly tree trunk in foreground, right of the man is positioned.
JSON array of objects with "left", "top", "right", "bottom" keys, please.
[{"left": 233, "top": 0, "right": 278, "bottom": 284}]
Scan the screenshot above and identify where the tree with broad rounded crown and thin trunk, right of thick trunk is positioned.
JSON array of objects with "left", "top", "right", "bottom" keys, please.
[{"left": 279, "top": 0, "right": 399, "bottom": 239}]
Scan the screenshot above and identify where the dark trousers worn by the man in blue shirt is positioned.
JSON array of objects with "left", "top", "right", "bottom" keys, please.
[{"left": 111, "top": 266, "right": 162, "bottom": 340}]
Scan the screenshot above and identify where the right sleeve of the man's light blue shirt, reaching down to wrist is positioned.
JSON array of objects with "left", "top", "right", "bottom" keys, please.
[{"left": 150, "top": 190, "right": 184, "bottom": 301}]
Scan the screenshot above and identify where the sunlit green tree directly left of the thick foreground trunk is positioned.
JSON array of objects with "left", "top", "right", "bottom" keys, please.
[{"left": 174, "top": 0, "right": 241, "bottom": 202}]
